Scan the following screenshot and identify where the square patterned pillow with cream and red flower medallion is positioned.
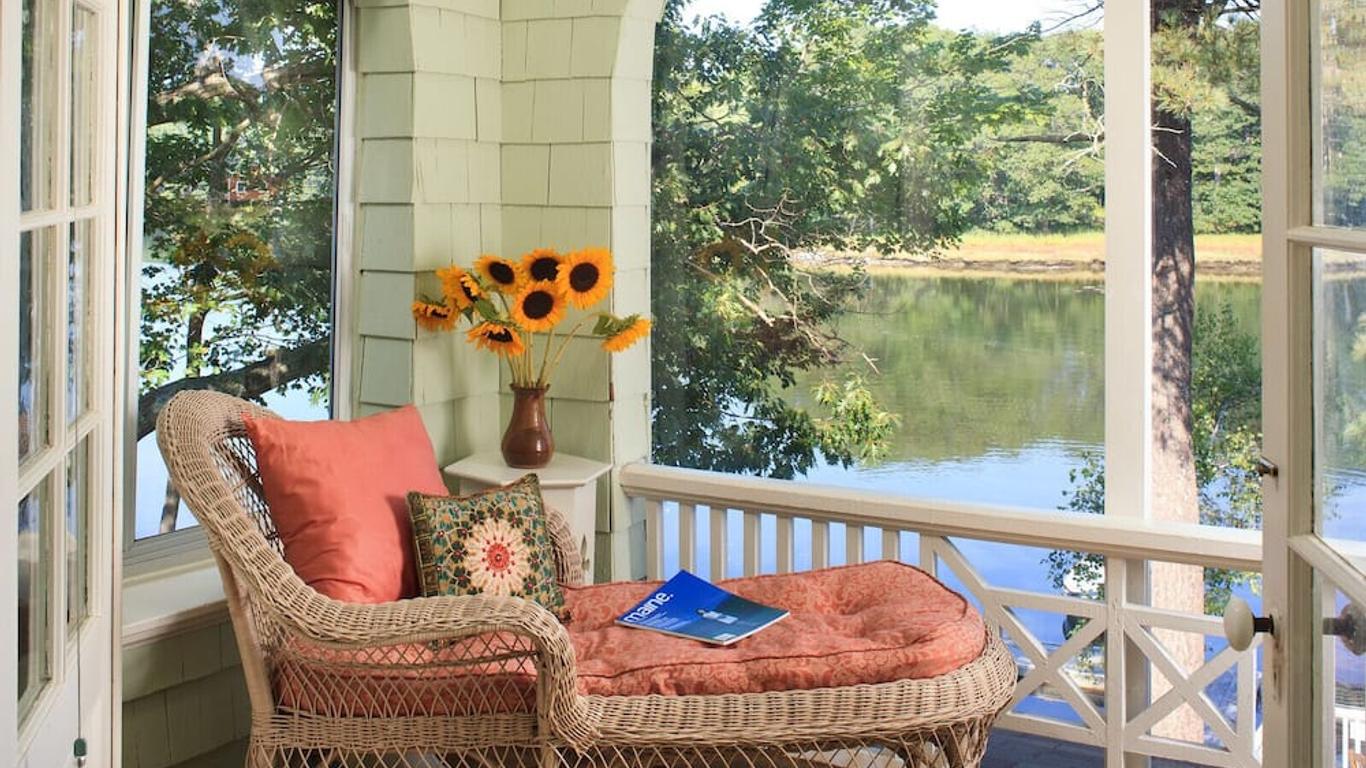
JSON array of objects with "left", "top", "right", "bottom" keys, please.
[{"left": 408, "top": 474, "right": 567, "bottom": 619}]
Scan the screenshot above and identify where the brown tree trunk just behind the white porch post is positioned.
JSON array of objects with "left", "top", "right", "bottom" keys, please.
[{"left": 1149, "top": 0, "right": 1205, "bottom": 742}]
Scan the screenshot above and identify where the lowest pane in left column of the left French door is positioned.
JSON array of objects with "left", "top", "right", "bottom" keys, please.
[{"left": 18, "top": 480, "right": 52, "bottom": 717}]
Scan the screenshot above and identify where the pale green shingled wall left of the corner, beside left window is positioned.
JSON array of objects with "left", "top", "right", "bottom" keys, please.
[{"left": 349, "top": 0, "right": 503, "bottom": 453}]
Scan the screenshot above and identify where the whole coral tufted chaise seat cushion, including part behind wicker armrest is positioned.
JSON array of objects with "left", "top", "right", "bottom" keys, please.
[{"left": 276, "top": 560, "right": 986, "bottom": 716}]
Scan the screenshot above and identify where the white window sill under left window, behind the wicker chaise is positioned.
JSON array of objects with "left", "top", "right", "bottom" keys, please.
[{"left": 122, "top": 549, "right": 228, "bottom": 648}]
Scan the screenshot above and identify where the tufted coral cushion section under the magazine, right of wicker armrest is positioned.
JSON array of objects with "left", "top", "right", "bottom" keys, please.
[{"left": 566, "top": 560, "right": 986, "bottom": 696}]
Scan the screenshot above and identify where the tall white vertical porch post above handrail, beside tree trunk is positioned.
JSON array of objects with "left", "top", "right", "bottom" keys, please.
[{"left": 1105, "top": 0, "right": 1153, "bottom": 519}]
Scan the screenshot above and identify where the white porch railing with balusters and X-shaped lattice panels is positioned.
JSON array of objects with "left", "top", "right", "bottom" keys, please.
[{"left": 620, "top": 463, "right": 1262, "bottom": 768}]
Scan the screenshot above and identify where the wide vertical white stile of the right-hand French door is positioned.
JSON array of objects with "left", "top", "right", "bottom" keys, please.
[{"left": 1261, "top": 0, "right": 1321, "bottom": 768}]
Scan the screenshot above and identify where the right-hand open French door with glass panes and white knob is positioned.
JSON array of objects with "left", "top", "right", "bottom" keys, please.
[{"left": 1262, "top": 0, "right": 1366, "bottom": 768}]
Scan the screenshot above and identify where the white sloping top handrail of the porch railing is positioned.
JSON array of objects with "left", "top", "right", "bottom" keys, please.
[{"left": 619, "top": 463, "right": 1262, "bottom": 571}]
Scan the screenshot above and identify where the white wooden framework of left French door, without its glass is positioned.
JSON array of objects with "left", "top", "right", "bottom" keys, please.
[{"left": 0, "top": 0, "right": 127, "bottom": 768}]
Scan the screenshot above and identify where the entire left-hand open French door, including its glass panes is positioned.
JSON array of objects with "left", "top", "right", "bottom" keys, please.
[{"left": 0, "top": 0, "right": 120, "bottom": 768}]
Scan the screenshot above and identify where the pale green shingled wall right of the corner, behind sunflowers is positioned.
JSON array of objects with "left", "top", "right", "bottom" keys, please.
[{"left": 501, "top": 0, "right": 663, "bottom": 581}]
